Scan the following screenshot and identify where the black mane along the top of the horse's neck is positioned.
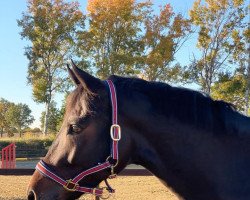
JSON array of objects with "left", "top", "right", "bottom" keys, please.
[{"left": 110, "top": 76, "right": 250, "bottom": 135}]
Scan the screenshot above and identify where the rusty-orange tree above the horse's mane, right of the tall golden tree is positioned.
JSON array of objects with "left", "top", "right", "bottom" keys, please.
[{"left": 143, "top": 4, "right": 192, "bottom": 81}]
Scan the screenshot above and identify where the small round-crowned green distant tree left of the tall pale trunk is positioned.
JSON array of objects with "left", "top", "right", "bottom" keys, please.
[{"left": 6, "top": 103, "right": 34, "bottom": 137}]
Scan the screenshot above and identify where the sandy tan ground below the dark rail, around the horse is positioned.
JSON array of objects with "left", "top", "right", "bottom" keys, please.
[{"left": 0, "top": 176, "right": 178, "bottom": 200}]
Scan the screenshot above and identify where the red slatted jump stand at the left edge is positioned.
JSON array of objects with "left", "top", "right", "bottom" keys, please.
[{"left": 1, "top": 143, "right": 16, "bottom": 169}]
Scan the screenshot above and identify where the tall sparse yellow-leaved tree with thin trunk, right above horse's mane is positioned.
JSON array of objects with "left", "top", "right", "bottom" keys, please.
[{"left": 189, "top": 0, "right": 247, "bottom": 93}]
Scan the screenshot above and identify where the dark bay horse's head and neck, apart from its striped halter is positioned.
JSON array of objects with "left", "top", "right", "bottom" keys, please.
[{"left": 28, "top": 61, "right": 250, "bottom": 200}]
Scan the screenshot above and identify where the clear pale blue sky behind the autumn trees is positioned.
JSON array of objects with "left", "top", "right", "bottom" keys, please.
[{"left": 0, "top": 0, "right": 196, "bottom": 128}]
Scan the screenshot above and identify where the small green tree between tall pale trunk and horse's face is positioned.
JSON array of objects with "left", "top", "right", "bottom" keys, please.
[{"left": 40, "top": 101, "right": 61, "bottom": 133}]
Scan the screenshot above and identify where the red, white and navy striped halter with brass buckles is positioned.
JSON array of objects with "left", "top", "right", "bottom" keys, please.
[{"left": 36, "top": 80, "right": 121, "bottom": 199}]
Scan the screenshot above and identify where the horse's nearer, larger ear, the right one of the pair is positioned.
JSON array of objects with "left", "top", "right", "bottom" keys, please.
[{"left": 71, "top": 60, "right": 103, "bottom": 93}]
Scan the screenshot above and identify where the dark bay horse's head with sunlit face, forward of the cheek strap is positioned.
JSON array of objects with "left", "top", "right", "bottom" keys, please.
[{"left": 28, "top": 62, "right": 132, "bottom": 200}]
